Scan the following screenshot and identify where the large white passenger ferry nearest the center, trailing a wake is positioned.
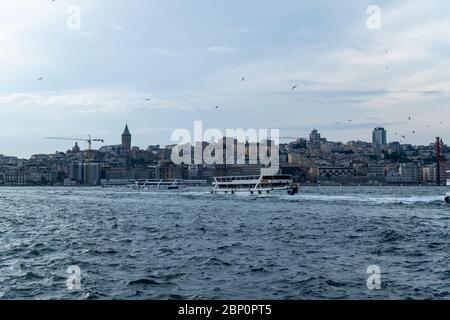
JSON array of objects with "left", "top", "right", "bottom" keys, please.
[{"left": 211, "top": 175, "right": 298, "bottom": 195}]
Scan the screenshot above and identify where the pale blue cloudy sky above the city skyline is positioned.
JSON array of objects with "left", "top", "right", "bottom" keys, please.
[{"left": 0, "top": 0, "right": 450, "bottom": 158}]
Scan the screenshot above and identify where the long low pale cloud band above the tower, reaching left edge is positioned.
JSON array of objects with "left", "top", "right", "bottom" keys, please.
[{"left": 0, "top": 90, "right": 223, "bottom": 116}]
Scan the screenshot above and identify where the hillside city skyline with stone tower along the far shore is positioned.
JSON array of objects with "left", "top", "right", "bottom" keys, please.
[{"left": 0, "top": 124, "right": 444, "bottom": 186}]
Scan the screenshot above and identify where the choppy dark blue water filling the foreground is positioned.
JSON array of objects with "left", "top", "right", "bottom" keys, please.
[{"left": 0, "top": 187, "right": 450, "bottom": 299}]
